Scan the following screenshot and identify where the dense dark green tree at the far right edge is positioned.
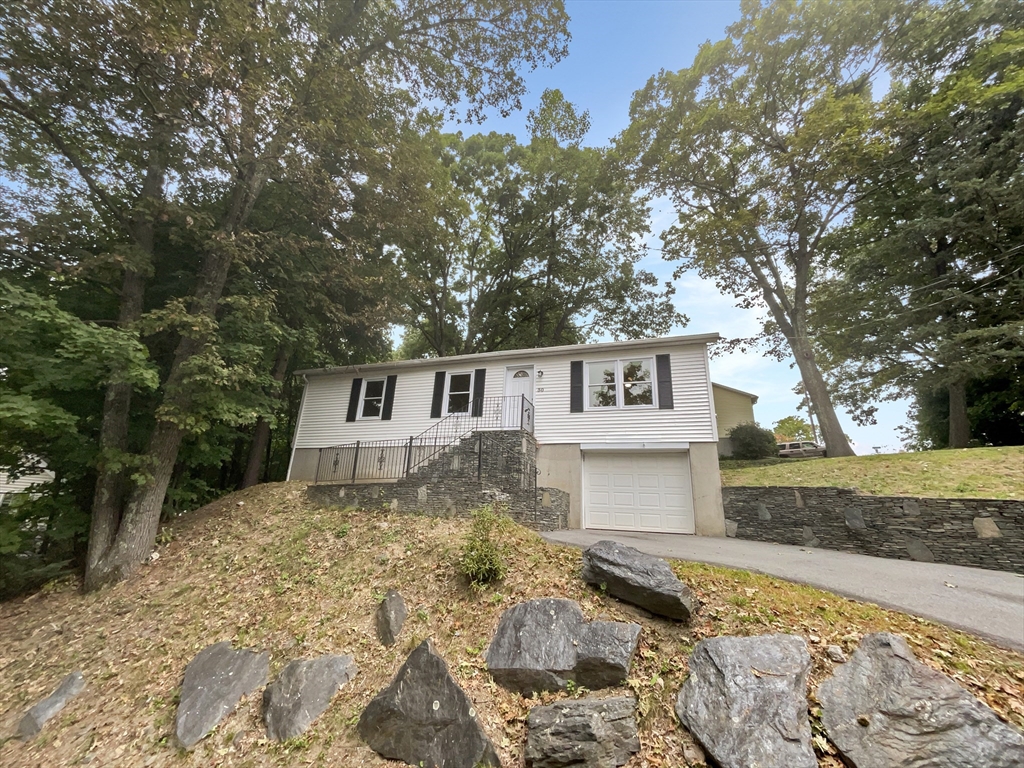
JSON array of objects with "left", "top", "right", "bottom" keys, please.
[{"left": 816, "top": 3, "right": 1024, "bottom": 447}]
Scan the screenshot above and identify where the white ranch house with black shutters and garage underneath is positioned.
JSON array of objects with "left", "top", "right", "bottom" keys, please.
[{"left": 289, "top": 334, "right": 725, "bottom": 536}]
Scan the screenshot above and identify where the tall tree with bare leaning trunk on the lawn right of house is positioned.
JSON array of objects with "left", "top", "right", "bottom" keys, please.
[{"left": 618, "top": 0, "right": 921, "bottom": 456}]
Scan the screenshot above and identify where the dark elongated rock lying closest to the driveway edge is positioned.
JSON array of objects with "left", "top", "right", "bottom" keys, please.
[{"left": 583, "top": 541, "right": 693, "bottom": 622}]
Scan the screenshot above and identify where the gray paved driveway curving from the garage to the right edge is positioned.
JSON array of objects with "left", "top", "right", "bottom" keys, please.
[{"left": 542, "top": 530, "right": 1024, "bottom": 651}]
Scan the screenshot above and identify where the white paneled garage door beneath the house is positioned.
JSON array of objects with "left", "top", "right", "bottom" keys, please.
[{"left": 584, "top": 452, "right": 693, "bottom": 534}]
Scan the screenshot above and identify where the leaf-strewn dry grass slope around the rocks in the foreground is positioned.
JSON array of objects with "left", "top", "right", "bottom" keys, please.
[{"left": 0, "top": 483, "right": 1024, "bottom": 768}]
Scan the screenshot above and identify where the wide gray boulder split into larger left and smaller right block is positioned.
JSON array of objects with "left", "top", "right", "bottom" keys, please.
[{"left": 486, "top": 598, "right": 640, "bottom": 695}]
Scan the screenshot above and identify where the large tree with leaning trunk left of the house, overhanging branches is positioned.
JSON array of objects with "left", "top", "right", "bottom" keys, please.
[{"left": 0, "top": 0, "right": 566, "bottom": 588}]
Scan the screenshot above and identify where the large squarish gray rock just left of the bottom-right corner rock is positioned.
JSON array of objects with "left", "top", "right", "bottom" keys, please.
[{"left": 676, "top": 635, "right": 818, "bottom": 768}]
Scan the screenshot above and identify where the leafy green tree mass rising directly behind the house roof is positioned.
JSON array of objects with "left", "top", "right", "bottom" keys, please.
[{"left": 399, "top": 90, "right": 685, "bottom": 356}]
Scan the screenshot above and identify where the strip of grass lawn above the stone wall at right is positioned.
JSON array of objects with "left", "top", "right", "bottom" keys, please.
[{"left": 722, "top": 445, "right": 1024, "bottom": 499}]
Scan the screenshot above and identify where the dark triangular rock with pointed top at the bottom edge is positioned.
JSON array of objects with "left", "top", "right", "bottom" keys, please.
[{"left": 358, "top": 640, "right": 501, "bottom": 768}]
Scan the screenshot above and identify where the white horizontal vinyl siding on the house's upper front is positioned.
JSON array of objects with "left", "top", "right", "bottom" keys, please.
[{"left": 295, "top": 343, "right": 717, "bottom": 449}]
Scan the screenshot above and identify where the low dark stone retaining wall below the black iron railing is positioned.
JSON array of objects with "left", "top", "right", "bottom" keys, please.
[{"left": 306, "top": 477, "right": 569, "bottom": 530}]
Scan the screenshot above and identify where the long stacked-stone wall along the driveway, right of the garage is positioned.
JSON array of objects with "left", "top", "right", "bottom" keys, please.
[{"left": 722, "top": 486, "right": 1024, "bottom": 573}]
